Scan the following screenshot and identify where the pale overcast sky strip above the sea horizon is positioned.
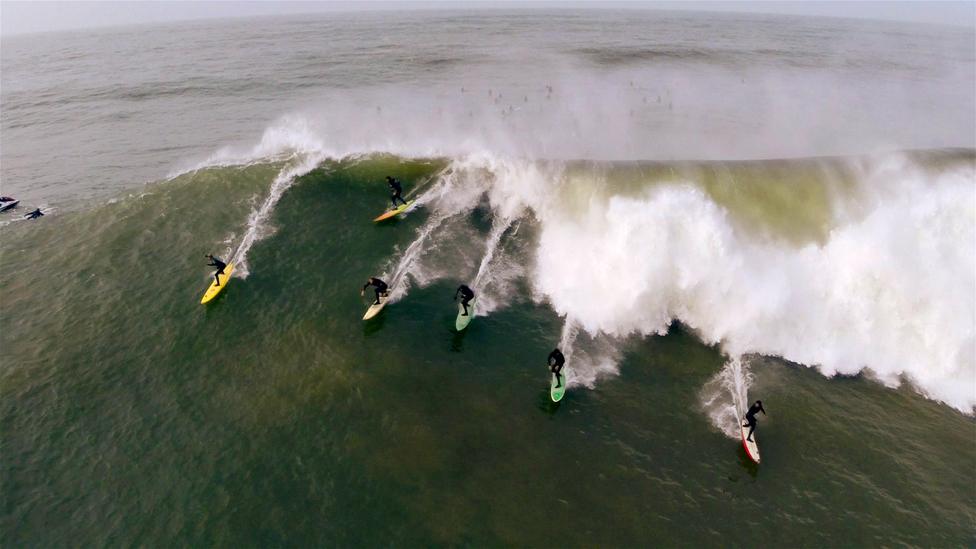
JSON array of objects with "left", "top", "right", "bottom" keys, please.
[{"left": 0, "top": 0, "right": 976, "bottom": 35}]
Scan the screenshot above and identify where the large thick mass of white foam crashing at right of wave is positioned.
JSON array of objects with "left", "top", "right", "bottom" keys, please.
[{"left": 535, "top": 154, "right": 976, "bottom": 413}]
